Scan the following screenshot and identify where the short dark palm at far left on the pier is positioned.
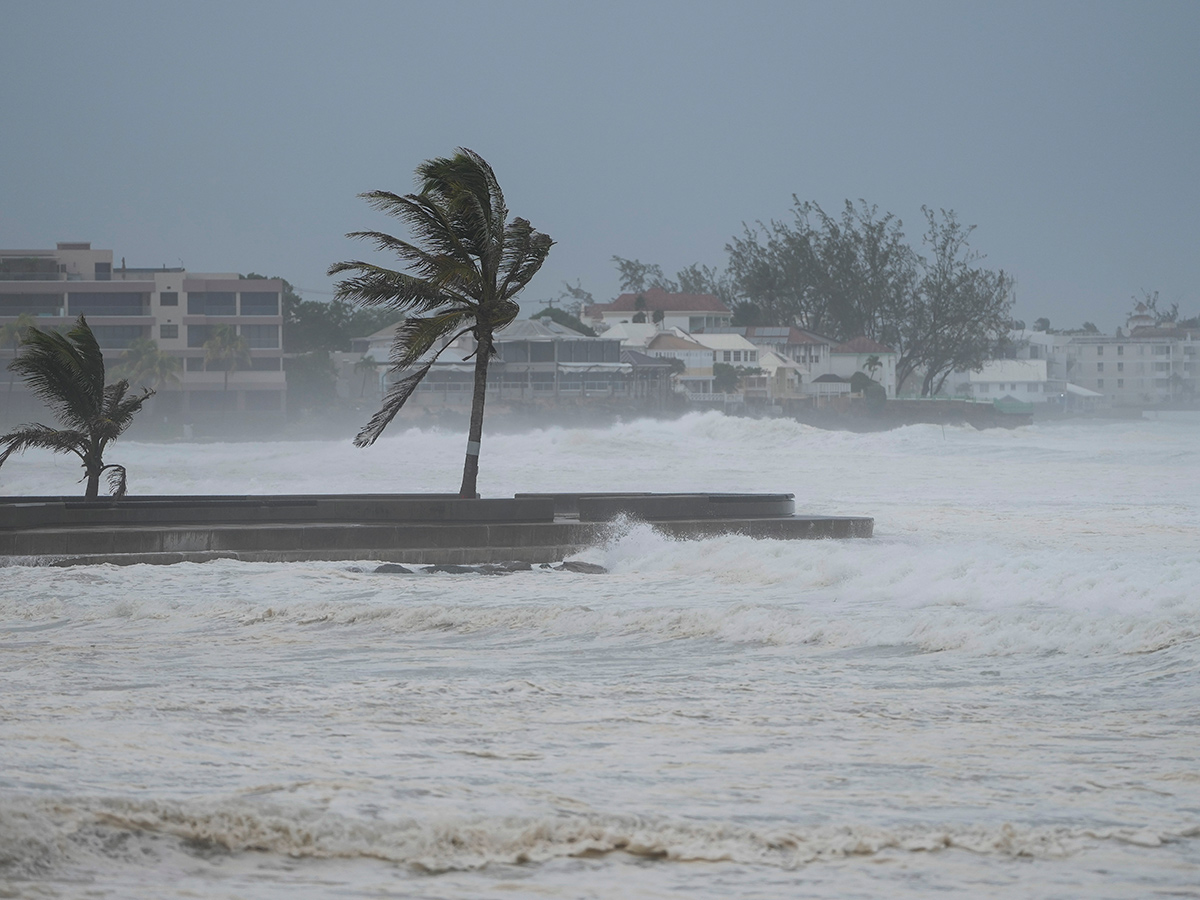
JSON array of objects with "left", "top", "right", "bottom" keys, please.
[{"left": 0, "top": 316, "right": 154, "bottom": 500}]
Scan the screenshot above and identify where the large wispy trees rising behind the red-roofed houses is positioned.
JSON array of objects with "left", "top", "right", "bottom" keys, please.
[{"left": 568, "top": 196, "right": 1014, "bottom": 396}]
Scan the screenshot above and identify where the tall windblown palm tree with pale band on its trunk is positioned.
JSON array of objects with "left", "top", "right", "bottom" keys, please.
[{"left": 329, "top": 148, "right": 553, "bottom": 497}]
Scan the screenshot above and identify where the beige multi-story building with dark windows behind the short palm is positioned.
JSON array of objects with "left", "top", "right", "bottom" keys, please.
[{"left": 0, "top": 242, "right": 286, "bottom": 418}]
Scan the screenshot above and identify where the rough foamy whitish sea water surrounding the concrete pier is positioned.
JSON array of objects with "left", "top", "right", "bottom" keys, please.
[{"left": 0, "top": 414, "right": 1200, "bottom": 900}]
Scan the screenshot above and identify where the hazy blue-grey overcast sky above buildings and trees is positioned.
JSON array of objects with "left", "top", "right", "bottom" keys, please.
[{"left": 0, "top": 0, "right": 1200, "bottom": 331}]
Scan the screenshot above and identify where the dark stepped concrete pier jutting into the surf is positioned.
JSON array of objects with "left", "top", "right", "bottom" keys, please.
[{"left": 0, "top": 493, "right": 874, "bottom": 565}]
